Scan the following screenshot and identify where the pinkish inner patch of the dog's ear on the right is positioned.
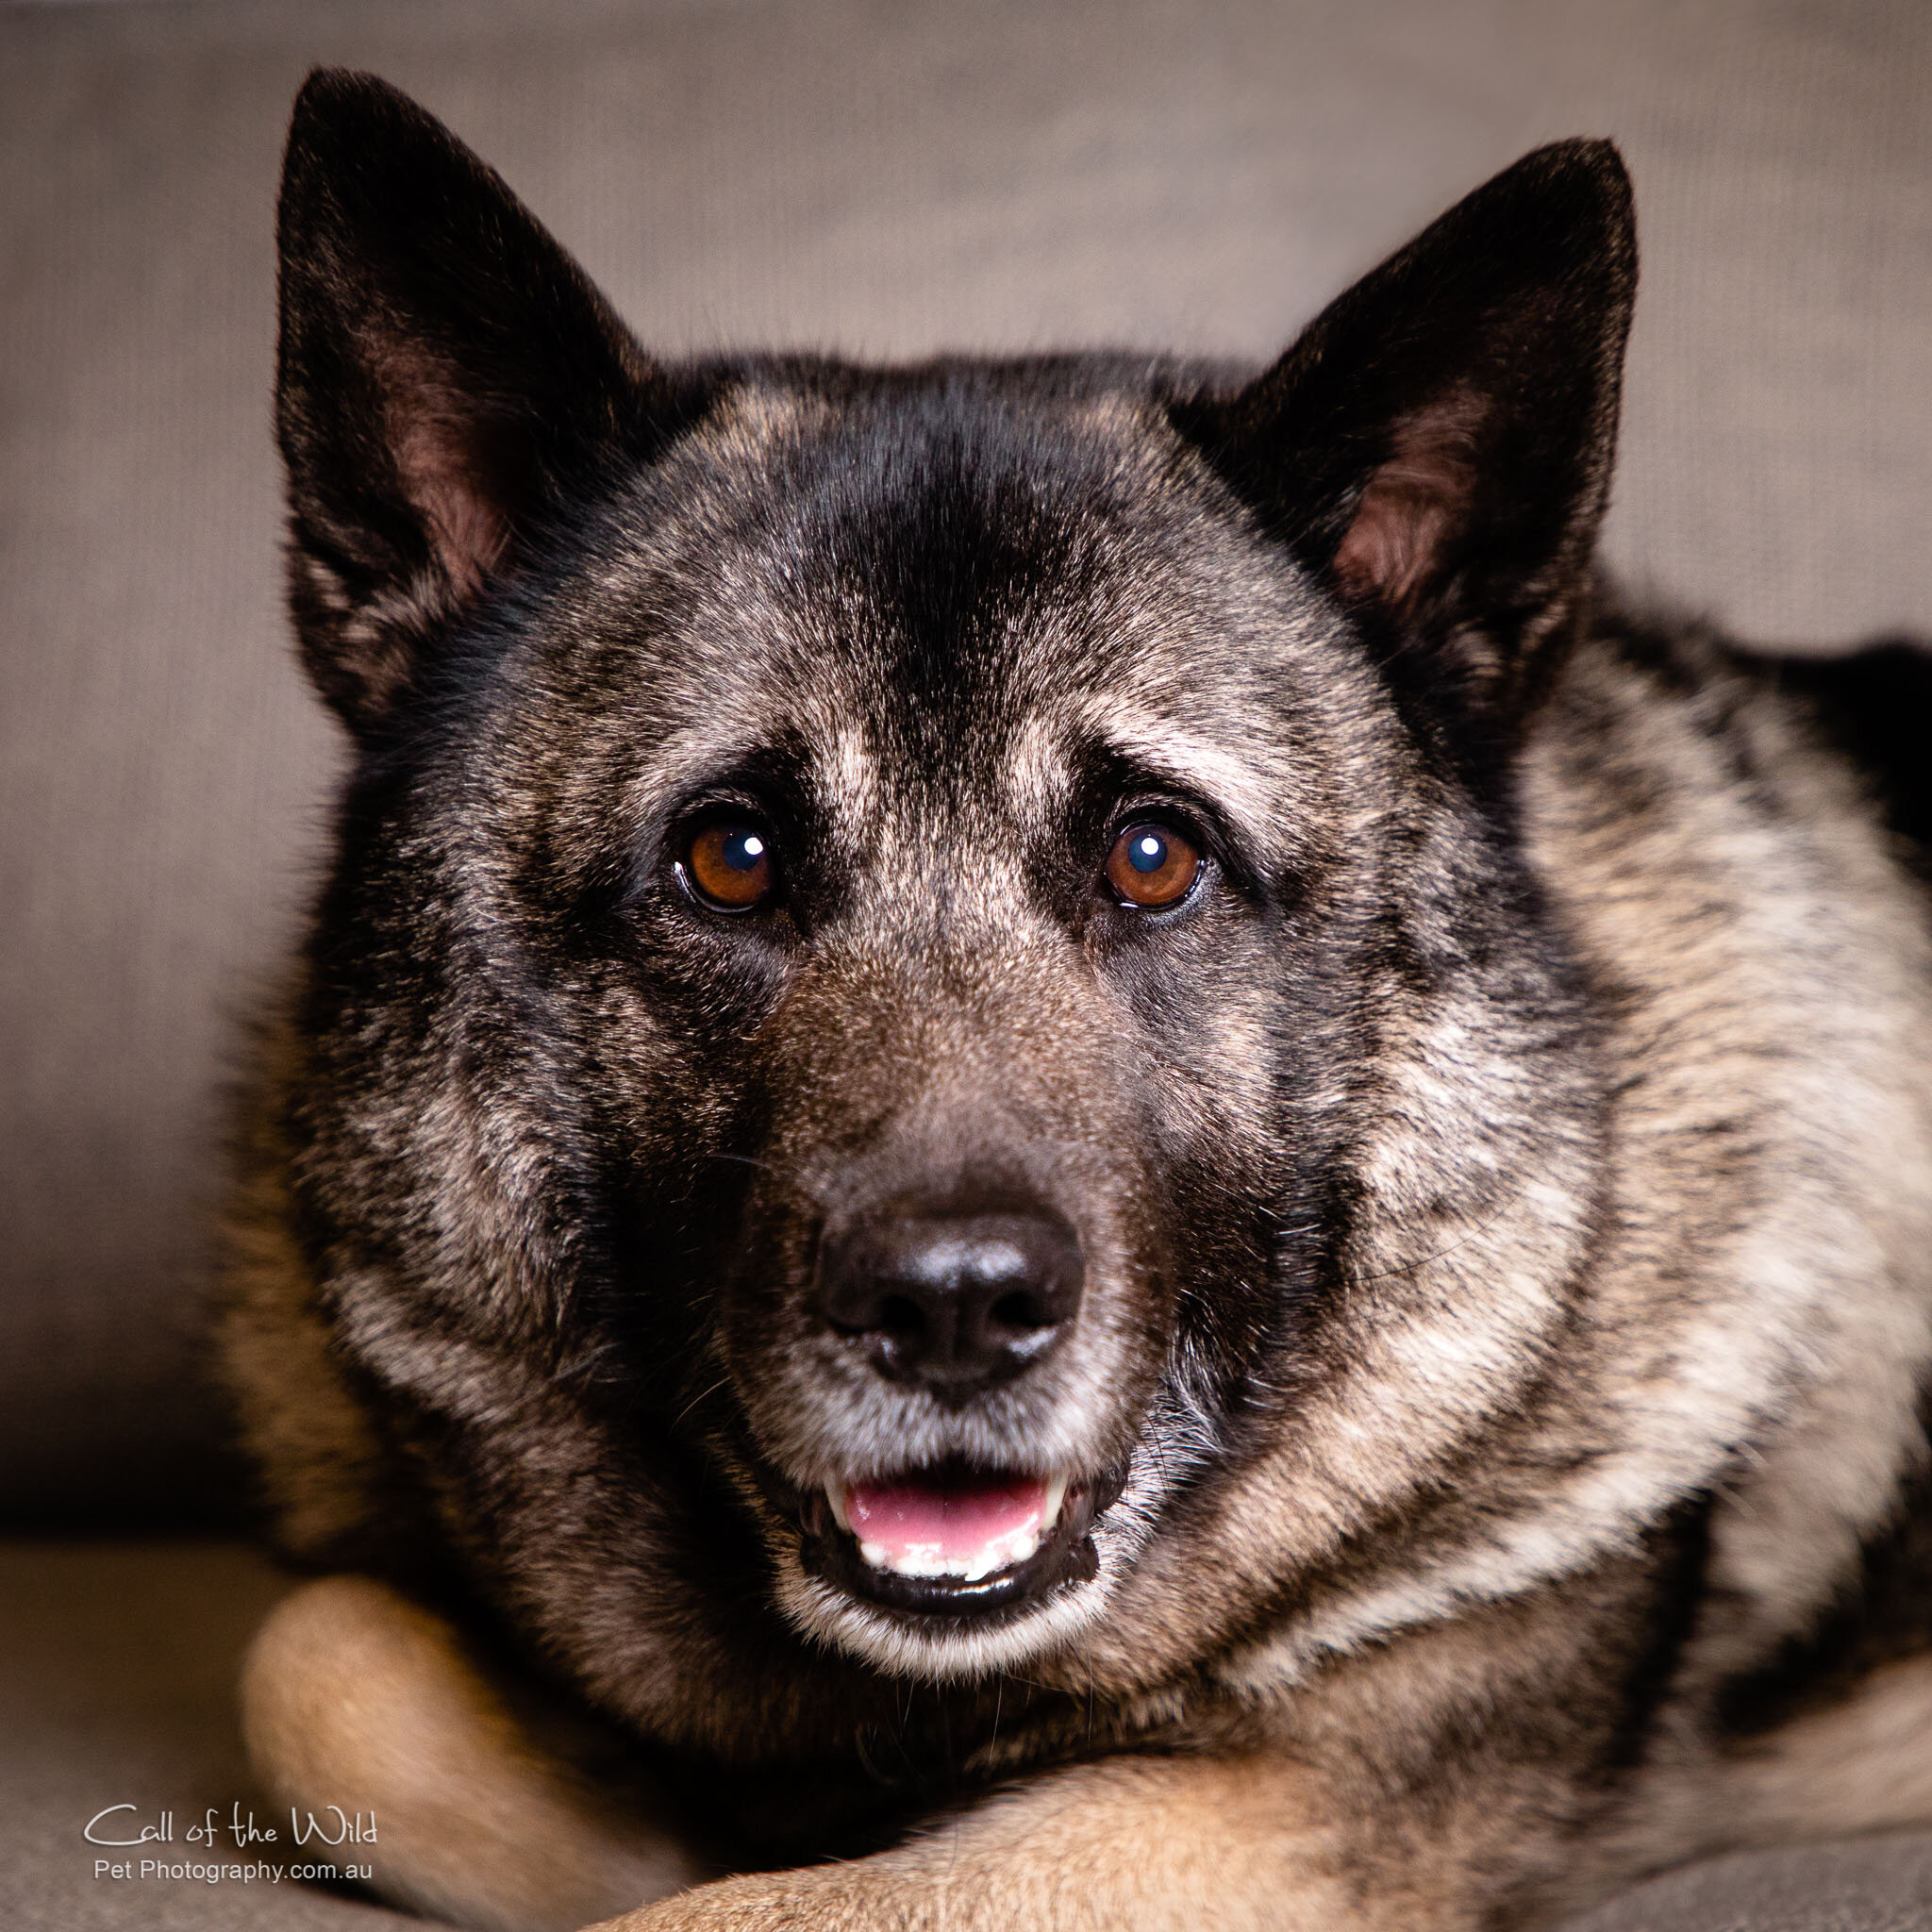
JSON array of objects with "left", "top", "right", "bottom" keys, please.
[{"left": 1333, "top": 391, "right": 1488, "bottom": 616}]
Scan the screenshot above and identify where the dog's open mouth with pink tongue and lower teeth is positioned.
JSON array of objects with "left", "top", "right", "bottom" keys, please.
[{"left": 804, "top": 1464, "right": 1121, "bottom": 1617}]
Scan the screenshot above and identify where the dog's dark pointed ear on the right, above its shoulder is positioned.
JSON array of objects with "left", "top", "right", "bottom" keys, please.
[{"left": 1174, "top": 142, "right": 1637, "bottom": 699}]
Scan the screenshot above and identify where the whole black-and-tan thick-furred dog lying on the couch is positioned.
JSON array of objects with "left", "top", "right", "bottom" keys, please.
[{"left": 225, "top": 74, "right": 1932, "bottom": 1932}]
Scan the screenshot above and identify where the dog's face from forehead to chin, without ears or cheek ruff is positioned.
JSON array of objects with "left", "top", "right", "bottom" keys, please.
[{"left": 427, "top": 371, "right": 1401, "bottom": 1667}]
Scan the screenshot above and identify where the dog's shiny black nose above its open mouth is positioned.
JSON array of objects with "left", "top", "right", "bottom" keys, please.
[{"left": 819, "top": 1213, "right": 1082, "bottom": 1397}]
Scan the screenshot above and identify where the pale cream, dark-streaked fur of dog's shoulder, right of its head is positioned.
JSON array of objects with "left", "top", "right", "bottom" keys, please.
[{"left": 1523, "top": 601, "right": 1932, "bottom": 1707}]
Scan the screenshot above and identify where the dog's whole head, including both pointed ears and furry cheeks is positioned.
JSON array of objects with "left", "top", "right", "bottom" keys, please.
[{"left": 280, "top": 77, "right": 1631, "bottom": 1709}]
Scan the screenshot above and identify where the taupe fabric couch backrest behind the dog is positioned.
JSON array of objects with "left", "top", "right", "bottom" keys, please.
[{"left": 0, "top": 0, "right": 1932, "bottom": 1519}]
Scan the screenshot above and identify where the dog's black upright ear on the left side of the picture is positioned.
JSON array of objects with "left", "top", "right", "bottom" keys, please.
[{"left": 276, "top": 70, "right": 684, "bottom": 734}]
